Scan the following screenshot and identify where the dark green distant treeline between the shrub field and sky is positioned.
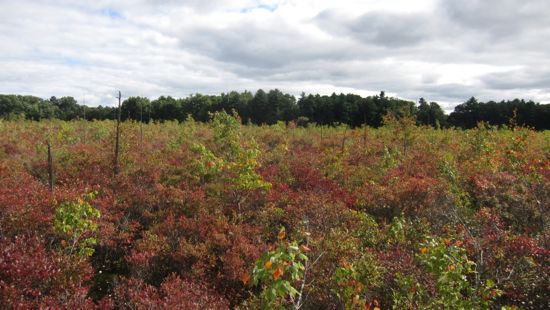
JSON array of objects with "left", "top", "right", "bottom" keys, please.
[{"left": 0, "top": 89, "right": 550, "bottom": 130}]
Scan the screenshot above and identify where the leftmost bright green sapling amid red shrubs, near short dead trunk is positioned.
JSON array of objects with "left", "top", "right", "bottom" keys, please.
[{"left": 53, "top": 192, "right": 101, "bottom": 256}]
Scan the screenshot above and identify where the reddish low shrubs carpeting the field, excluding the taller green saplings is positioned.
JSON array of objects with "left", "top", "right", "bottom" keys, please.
[{"left": 0, "top": 122, "right": 550, "bottom": 309}]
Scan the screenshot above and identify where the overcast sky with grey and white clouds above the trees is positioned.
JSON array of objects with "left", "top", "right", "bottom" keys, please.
[{"left": 0, "top": 0, "right": 550, "bottom": 110}]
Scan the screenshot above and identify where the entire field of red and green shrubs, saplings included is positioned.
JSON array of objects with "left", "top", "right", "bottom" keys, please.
[{"left": 0, "top": 112, "right": 550, "bottom": 309}]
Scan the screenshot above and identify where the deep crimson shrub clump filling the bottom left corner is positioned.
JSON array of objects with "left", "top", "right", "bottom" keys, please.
[{"left": 0, "top": 236, "right": 93, "bottom": 309}]
